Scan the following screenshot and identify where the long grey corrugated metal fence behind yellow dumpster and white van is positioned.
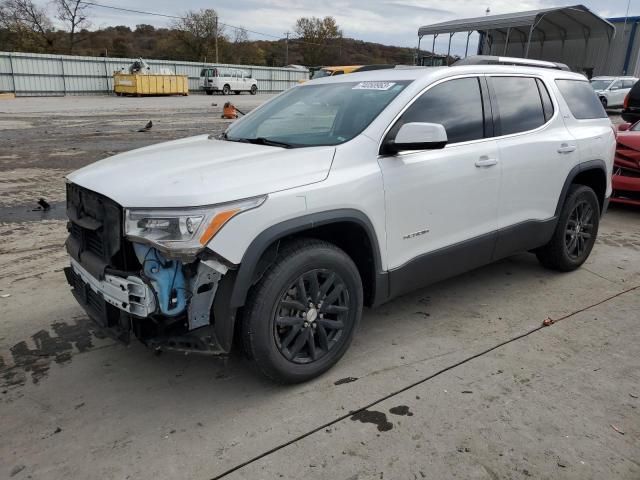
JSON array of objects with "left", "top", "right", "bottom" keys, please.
[{"left": 0, "top": 52, "right": 309, "bottom": 96}]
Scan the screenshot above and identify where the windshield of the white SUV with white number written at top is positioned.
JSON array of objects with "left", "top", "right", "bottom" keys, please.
[{"left": 223, "top": 81, "right": 410, "bottom": 147}]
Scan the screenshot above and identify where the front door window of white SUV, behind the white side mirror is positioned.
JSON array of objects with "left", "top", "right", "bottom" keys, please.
[{"left": 392, "top": 77, "right": 485, "bottom": 143}]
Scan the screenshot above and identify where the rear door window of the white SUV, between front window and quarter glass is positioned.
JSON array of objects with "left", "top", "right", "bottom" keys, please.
[{"left": 490, "top": 77, "right": 546, "bottom": 135}]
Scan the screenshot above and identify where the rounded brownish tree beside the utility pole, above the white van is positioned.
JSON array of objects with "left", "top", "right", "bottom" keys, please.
[{"left": 173, "top": 8, "right": 224, "bottom": 62}]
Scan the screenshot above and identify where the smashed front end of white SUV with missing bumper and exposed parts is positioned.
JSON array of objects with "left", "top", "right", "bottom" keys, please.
[{"left": 65, "top": 183, "right": 258, "bottom": 355}]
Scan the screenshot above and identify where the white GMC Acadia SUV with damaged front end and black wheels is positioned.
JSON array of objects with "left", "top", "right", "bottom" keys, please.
[{"left": 66, "top": 61, "right": 615, "bottom": 382}]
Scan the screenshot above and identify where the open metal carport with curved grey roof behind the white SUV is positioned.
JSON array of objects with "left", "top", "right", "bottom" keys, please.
[{"left": 418, "top": 5, "right": 615, "bottom": 70}]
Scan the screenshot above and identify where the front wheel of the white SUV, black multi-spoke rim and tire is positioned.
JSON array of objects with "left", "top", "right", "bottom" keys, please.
[{"left": 242, "top": 239, "right": 363, "bottom": 383}]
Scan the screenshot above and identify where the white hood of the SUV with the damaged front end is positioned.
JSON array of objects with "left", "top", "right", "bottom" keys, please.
[{"left": 67, "top": 135, "right": 335, "bottom": 207}]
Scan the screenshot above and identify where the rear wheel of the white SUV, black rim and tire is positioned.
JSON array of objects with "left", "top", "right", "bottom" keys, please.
[{"left": 536, "top": 185, "right": 600, "bottom": 272}]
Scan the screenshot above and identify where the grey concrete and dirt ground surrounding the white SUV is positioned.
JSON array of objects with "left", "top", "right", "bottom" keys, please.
[{"left": 0, "top": 95, "right": 640, "bottom": 480}]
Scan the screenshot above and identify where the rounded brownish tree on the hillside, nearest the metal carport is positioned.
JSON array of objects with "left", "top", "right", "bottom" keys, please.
[{"left": 294, "top": 17, "right": 342, "bottom": 66}]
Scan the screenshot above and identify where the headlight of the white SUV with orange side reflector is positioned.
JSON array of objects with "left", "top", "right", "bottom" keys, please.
[{"left": 124, "top": 196, "right": 267, "bottom": 255}]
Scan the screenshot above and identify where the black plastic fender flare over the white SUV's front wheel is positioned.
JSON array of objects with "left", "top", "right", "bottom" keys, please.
[{"left": 229, "top": 209, "right": 382, "bottom": 308}]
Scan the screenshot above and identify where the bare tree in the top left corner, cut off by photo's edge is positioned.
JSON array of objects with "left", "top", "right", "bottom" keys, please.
[{"left": 0, "top": 0, "right": 54, "bottom": 48}]
